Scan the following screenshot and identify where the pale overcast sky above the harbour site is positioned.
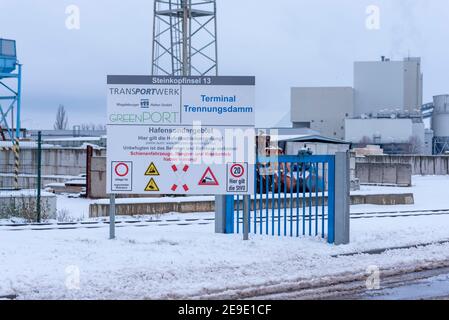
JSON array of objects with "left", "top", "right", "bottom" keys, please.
[{"left": 0, "top": 0, "right": 449, "bottom": 129}]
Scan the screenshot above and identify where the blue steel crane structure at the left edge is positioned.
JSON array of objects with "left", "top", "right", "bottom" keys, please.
[{"left": 0, "top": 39, "right": 22, "bottom": 142}]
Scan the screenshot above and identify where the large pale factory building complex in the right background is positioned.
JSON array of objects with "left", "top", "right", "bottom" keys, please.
[{"left": 291, "top": 57, "right": 449, "bottom": 154}]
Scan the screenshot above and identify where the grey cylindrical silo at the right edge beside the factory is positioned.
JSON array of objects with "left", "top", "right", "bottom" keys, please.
[{"left": 432, "top": 95, "right": 449, "bottom": 154}]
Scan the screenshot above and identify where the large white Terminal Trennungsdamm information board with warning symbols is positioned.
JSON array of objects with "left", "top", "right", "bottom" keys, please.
[{"left": 107, "top": 76, "right": 255, "bottom": 195}]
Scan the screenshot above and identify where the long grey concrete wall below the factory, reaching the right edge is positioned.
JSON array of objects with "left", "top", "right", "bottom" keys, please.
[{"left": 356, "top": 155, "right": 449, "bottom": 175}]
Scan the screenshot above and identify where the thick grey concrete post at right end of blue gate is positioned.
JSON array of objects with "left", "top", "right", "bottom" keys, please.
[{"left": 335, "top": 152, "right": 351, "bottom": 245}]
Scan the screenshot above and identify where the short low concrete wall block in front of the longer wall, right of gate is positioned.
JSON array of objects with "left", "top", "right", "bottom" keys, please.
[{"left": 355, "top": 163, "right": 412, "bottom": 187}]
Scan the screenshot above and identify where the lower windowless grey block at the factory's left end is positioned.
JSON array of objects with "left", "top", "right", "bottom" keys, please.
[{"left": 291, "top": 87, "right": 354, "bottom": 140}]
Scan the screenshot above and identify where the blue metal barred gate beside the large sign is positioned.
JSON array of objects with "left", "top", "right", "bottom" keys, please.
[{"left": 226, "top": 155, "right": 335, "bottom": 243}]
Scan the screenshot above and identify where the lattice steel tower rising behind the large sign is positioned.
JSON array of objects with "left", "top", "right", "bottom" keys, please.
[{"left": 152, "top": 0, "right": 218, "bottom": 76}]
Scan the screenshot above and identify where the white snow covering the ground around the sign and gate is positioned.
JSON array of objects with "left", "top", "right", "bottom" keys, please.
[{"left": 0, "top": 177, "right": 449, "bottom": 299}]
